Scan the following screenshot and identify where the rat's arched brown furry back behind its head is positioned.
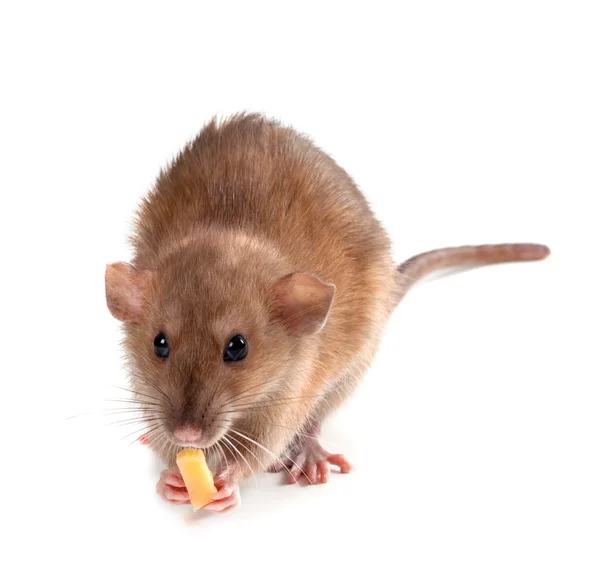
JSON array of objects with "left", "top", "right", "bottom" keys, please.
[{"left": 133, "top": 115, "right": 396, "bottom": 388}]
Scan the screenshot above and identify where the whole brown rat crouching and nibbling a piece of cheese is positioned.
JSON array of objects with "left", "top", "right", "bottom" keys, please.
[{"left": 105, "top": 113, "right": 549, "bottom": 512}]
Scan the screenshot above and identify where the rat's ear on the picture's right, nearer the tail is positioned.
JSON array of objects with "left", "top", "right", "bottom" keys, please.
[{"left": 275, "top": 274, "right": 335, "bottom": 336}]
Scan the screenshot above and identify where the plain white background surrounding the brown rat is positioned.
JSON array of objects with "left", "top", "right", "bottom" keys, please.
[{"left": 0, "top": 0, "right": 600, "bottom": 580}]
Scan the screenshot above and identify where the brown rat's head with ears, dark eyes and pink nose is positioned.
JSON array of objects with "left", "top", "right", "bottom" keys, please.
[{"left": 106, "top": 238, "right": 335, "bottom": 448}]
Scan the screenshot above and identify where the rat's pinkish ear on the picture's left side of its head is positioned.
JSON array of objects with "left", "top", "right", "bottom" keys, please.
[{"left": 104, "top": 262, "right": 147, "bottom": 322}]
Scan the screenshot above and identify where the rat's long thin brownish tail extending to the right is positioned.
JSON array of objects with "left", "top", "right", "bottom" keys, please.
[{"left": 396, "top": 244, "right": 550, "bottom": 304}]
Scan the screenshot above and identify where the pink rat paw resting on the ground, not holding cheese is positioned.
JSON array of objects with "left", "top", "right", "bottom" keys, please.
[{"left": 286, "top": 439, "right": 352, "bottom": 485}]
